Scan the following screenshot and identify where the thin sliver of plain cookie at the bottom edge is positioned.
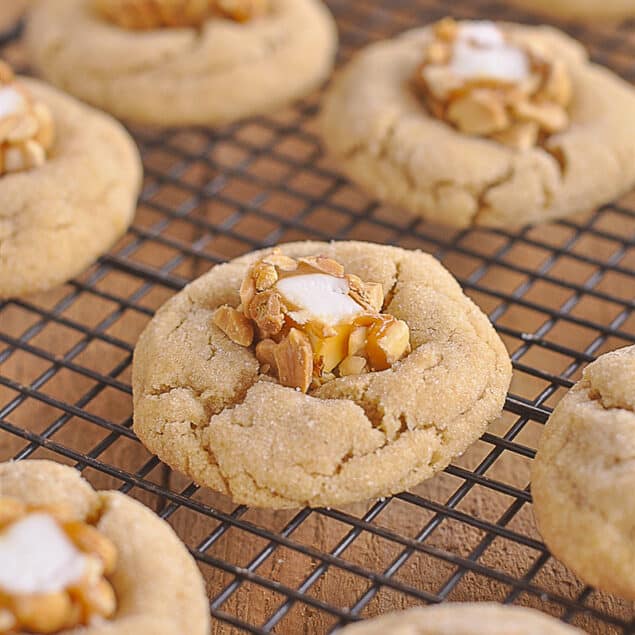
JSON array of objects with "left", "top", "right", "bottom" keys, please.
[{"left": 340, "top": 602, "right": 583, "bottom": 635}]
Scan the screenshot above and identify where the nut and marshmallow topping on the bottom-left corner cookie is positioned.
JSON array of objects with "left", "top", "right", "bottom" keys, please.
[{"left": 0, "top": 498, "right": 117, "bottom": 635}]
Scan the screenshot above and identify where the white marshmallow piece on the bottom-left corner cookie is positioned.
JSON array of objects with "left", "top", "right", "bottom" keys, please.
[{"left": 0, "top": 513, "right": 86, "bottom": 594}]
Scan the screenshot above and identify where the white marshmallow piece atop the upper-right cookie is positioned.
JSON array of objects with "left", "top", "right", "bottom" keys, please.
[{"left": 450, "top": 22, "right": 530, "bottom": 82}]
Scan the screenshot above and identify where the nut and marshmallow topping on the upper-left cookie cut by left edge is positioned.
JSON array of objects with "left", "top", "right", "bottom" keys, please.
[{"left": 0, "top": 61, "right": 55, "bottom": 175}]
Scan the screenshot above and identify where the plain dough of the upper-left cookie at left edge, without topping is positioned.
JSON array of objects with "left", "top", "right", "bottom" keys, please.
[{"left": 0, "top": 78, "right": 142, "bottom": 297}]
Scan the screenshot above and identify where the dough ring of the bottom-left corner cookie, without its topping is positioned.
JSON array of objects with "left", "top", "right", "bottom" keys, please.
[{"left": 0, "top": 460, "right": 209, "bottom": 635}]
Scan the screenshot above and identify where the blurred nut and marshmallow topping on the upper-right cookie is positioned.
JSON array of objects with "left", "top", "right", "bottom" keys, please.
[{"left": 415, "top": 18, "right": 573, "bottom": 150}]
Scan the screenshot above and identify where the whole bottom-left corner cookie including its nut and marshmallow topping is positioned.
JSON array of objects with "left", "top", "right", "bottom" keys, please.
[{"left": 0, "top": 460, "right": 210, "bottom": 635}]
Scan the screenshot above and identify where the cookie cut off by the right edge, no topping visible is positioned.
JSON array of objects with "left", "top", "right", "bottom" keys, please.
[{"left": 531, "top": 346, "right": 635, "bottom": 600}]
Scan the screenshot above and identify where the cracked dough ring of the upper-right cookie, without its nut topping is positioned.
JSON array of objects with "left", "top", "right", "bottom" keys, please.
[{"left": 321, "top": 25, "right": 635, "bottom": 227}]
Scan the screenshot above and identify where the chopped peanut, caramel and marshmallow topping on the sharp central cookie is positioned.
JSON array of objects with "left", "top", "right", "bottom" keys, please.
[{"left": 214, "top": 250, "right": 410, "bottom": 392}]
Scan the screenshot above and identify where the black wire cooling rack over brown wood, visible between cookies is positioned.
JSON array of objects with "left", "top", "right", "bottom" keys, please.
[{"left": 0, "top": 0, "right": 635, "bottom": 633}]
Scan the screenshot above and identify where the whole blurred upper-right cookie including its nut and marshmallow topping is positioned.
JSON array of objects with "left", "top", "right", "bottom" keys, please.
[{"left": 321, "top": 21, "right": 635, "bottom": 227}]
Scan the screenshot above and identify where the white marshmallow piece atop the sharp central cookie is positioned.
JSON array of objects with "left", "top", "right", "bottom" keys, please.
[{"left": 276, "top": 273, "right": 363, "bottom": 326}]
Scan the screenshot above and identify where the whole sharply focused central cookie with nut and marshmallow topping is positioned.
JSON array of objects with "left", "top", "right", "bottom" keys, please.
[{"left": 132, "top": 242, "right": 511, "bottom": 508}]
